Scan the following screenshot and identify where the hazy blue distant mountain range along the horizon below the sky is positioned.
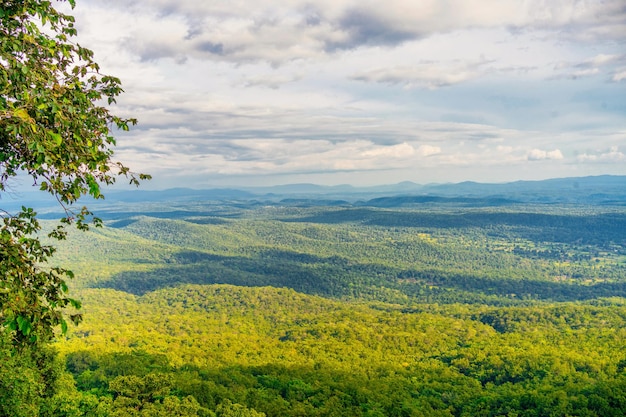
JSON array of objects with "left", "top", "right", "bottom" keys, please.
[{"left": 0, "top": 175, "right": 626, "bottom": 212}]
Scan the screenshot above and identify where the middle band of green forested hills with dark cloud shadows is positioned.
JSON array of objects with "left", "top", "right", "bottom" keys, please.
[{"left": 48, "top": 208, "right": 626, "bottom": 304}]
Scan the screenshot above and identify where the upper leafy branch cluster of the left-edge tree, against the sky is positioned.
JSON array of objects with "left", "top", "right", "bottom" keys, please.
[{"left": 0, "top": 0, "right": 147, "bottom": 204}]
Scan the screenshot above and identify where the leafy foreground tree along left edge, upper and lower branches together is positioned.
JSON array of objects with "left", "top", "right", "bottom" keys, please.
[{"left": 0, "top": 0, "right": 149, "bottom": 348}]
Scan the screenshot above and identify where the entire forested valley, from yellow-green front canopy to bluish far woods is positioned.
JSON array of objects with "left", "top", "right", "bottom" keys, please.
[{"left": 0, "top": 203, "right": 626, "bottom": 416}]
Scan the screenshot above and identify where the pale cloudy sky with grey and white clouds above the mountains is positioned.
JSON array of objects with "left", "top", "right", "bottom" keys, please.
[{"left": 66, "top": 0, "right": 626, "bottom": 188}]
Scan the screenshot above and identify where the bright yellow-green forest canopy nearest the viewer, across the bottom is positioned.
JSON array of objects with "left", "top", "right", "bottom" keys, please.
[{"left": 54, "top": 285, "right": 626, "bottom": 416}]
